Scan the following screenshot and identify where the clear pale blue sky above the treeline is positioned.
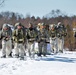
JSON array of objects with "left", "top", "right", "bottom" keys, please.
[{"left": 0, "top": 0, "right": 76, "bottom": 17}]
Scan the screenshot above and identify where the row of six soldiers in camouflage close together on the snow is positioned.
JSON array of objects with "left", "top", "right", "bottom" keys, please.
[{"left": 0, "top": 22, "right": 67, "bottom": 59}]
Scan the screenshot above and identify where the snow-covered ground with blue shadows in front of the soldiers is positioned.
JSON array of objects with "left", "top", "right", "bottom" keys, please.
[{"left": 0, "top": 51, "right": 76, "bottom": 75}]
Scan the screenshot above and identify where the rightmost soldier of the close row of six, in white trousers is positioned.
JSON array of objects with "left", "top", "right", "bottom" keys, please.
[{"left": 56, "top": 22, "right": 67, "bottom": 53}]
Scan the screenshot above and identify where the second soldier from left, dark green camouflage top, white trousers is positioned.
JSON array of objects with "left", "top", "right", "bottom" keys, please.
[{"left": 13, "top": 23, "right": 26, "bottom": 59}]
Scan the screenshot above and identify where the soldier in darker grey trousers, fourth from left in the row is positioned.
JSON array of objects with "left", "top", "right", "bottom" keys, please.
[{"left": 37, "top": 23, "right": 49, "bottom": 56}]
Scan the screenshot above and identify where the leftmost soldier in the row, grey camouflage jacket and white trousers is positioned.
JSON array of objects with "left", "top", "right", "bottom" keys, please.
[{"left": 1, "top": 24, "right": 12, "bottom": 58}]
